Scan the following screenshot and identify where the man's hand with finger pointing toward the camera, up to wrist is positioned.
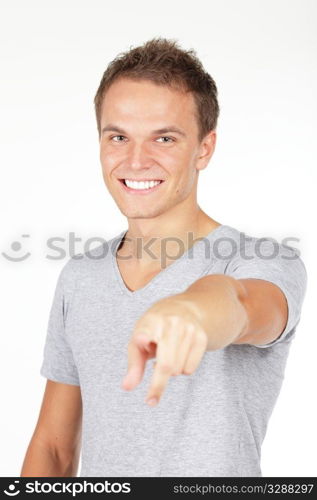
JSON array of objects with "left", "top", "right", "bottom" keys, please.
[{"left": 122, "top": 294, "right": 208, "bottom": 406}]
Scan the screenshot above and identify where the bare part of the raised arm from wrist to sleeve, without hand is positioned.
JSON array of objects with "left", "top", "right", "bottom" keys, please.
[{"left": 182, "top": 274, "right": 288, "bottom": 350}]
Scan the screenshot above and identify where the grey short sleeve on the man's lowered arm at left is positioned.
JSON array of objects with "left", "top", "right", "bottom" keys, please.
[{"left": 40, "top": 261, "right": 80, "bottom": 385}]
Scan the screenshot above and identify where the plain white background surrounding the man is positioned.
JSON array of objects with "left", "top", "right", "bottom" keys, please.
[{"left": 0, "top": 0, "right": 317, "bottom": 477}]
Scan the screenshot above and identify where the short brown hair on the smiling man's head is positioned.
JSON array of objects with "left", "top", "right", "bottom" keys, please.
[{"left": 94, "top": 37, "right": 219, "bottom": 142}]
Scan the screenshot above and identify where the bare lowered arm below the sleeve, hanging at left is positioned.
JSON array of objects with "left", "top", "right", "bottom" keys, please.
[{"left": 20, "top": 380, "right": 82, "bottom": 477}]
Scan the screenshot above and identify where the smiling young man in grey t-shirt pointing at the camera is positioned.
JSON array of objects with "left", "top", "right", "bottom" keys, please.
[{"left": 21, "top": 39, "right": 307, "bottom": 477}]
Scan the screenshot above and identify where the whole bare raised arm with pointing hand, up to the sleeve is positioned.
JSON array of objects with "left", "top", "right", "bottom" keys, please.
[{"left": 122, "top": 274, "right": 288, "bottom": 405}]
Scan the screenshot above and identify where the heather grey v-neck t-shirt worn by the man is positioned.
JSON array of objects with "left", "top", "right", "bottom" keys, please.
[{"left": 40, "top": 225, "right": 307, "bottom": 477}]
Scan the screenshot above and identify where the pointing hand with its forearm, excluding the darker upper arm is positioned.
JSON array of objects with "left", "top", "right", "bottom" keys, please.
[{"left": 122, "top": 275, "right": 250, "bottom": 405}]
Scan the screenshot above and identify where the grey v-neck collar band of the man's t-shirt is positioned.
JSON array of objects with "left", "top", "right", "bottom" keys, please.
[{"left": 110, "top": 224, "right": 229, "bottom": 297}]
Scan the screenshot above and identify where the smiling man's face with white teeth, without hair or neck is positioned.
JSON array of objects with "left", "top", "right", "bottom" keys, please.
[{"left": 100, "top": 78, "right": 212, "bottom": 218}]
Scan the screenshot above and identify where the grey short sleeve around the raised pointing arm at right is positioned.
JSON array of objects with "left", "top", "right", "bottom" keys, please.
[{"left": 225, "top": 237, "right": 307, "bottom": 348}]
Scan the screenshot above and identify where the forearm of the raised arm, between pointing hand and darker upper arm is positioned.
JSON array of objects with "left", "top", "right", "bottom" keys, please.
[{"left": 178, "top": 274, "right": 248, "bottom": 351}]
